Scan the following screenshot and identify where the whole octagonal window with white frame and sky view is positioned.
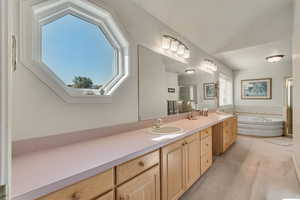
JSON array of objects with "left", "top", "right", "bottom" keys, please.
[{"left": 20, "top": 0, "right": 130, "bottom": 103}]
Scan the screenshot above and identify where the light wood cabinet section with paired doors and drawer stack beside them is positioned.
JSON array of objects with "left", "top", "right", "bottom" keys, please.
[{"left": 161, "top": 128, "right": 212, "bottom": 200}]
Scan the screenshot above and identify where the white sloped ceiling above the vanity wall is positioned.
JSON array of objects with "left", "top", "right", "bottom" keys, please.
[{"left": 132, "top": 0, "right": 293, "bottom": 69}]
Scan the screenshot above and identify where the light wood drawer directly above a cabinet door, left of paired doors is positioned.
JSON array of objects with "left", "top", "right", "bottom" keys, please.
[{"left": 116, "top": 151, "right": 159, "bottom": 184}]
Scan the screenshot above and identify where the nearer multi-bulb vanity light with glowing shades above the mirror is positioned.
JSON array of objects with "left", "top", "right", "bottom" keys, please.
[{"left": 162, "top": 35, "right": 190, "bottom": 59}]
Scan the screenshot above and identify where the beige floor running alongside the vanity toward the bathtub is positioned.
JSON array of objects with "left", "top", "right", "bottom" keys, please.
[{"left": 181, "top": 136, "right": 300, "bottom": 200}]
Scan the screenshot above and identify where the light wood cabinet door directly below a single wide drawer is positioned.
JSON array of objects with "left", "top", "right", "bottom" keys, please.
[{"left": 117, "top": 165, "right": 160, "bottom": 200}]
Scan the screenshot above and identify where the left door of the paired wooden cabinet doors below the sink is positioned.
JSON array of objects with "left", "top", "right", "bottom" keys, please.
[{"left": 162, "top": 140, "right": 186, "bottom": 200}]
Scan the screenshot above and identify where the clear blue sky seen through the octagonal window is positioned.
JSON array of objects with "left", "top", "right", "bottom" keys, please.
[{"left": 42, "top": 15, "right": 114, "bottom": 85}]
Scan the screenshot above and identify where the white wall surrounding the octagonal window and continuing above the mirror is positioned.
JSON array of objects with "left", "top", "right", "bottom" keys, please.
[{"left": 13, "top": 0, "right": 231, "bottom": 140}]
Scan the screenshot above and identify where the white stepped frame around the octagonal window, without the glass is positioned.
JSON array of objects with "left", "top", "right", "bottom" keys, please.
[{"left": 19, "top": 0, "right": 130, "bottom": 103}]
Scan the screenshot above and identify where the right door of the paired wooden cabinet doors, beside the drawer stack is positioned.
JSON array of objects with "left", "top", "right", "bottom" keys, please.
[{"left": 184, "top": 134, "right": 201, "bottom": 188}]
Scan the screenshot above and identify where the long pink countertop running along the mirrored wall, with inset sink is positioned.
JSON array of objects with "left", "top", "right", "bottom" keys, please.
[{"left": 12, "top": 113, "right": 232, "bottom": 200}]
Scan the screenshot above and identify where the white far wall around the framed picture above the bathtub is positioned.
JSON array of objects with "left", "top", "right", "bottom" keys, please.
[{"left": 234, "top": 63, "right": 292, "bottom": 114}]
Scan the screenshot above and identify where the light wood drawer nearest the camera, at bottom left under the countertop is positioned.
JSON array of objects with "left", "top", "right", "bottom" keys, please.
[{"left": 39, "top": 169, "right": 114, "bottom": 200}]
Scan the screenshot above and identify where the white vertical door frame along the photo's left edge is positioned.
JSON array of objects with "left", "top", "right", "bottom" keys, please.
[{"left": 0, "top": 0, "right": 12, "bottom": 195}]
